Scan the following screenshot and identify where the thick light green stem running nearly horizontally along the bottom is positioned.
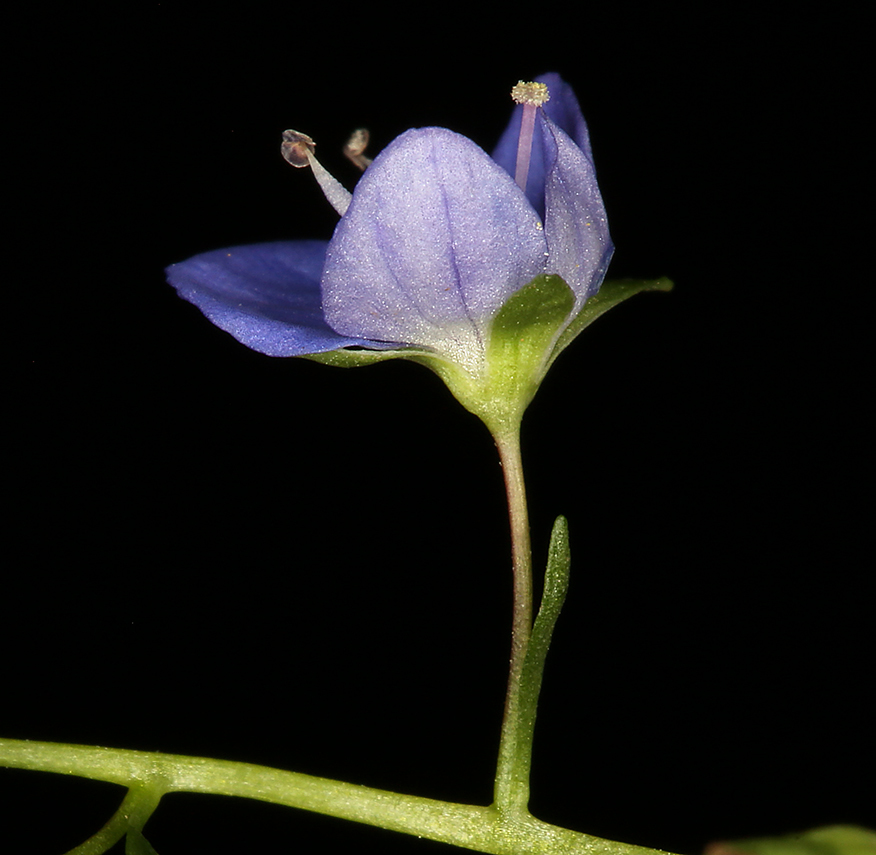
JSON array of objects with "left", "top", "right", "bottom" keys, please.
[{"left": 0, "top": 739, "right": 676, "bottom": 855}]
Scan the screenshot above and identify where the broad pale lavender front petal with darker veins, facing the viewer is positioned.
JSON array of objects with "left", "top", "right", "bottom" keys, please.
[{"left": 322, "top": 128, "right": 548, "bottom": 367}]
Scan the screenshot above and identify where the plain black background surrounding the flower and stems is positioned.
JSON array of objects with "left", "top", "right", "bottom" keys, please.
[{"left": 0, "top": 3, "right": 874, "bottom": 855}]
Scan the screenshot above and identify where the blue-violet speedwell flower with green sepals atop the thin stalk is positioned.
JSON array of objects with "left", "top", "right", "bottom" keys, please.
[{"left": 167, "top": 74, "right": 664, "bottom": 432}]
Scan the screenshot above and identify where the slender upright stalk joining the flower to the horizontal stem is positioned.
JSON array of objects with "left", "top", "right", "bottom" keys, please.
[{"left": 494, "top": 422, "right": 533, "bottom": 812}]
